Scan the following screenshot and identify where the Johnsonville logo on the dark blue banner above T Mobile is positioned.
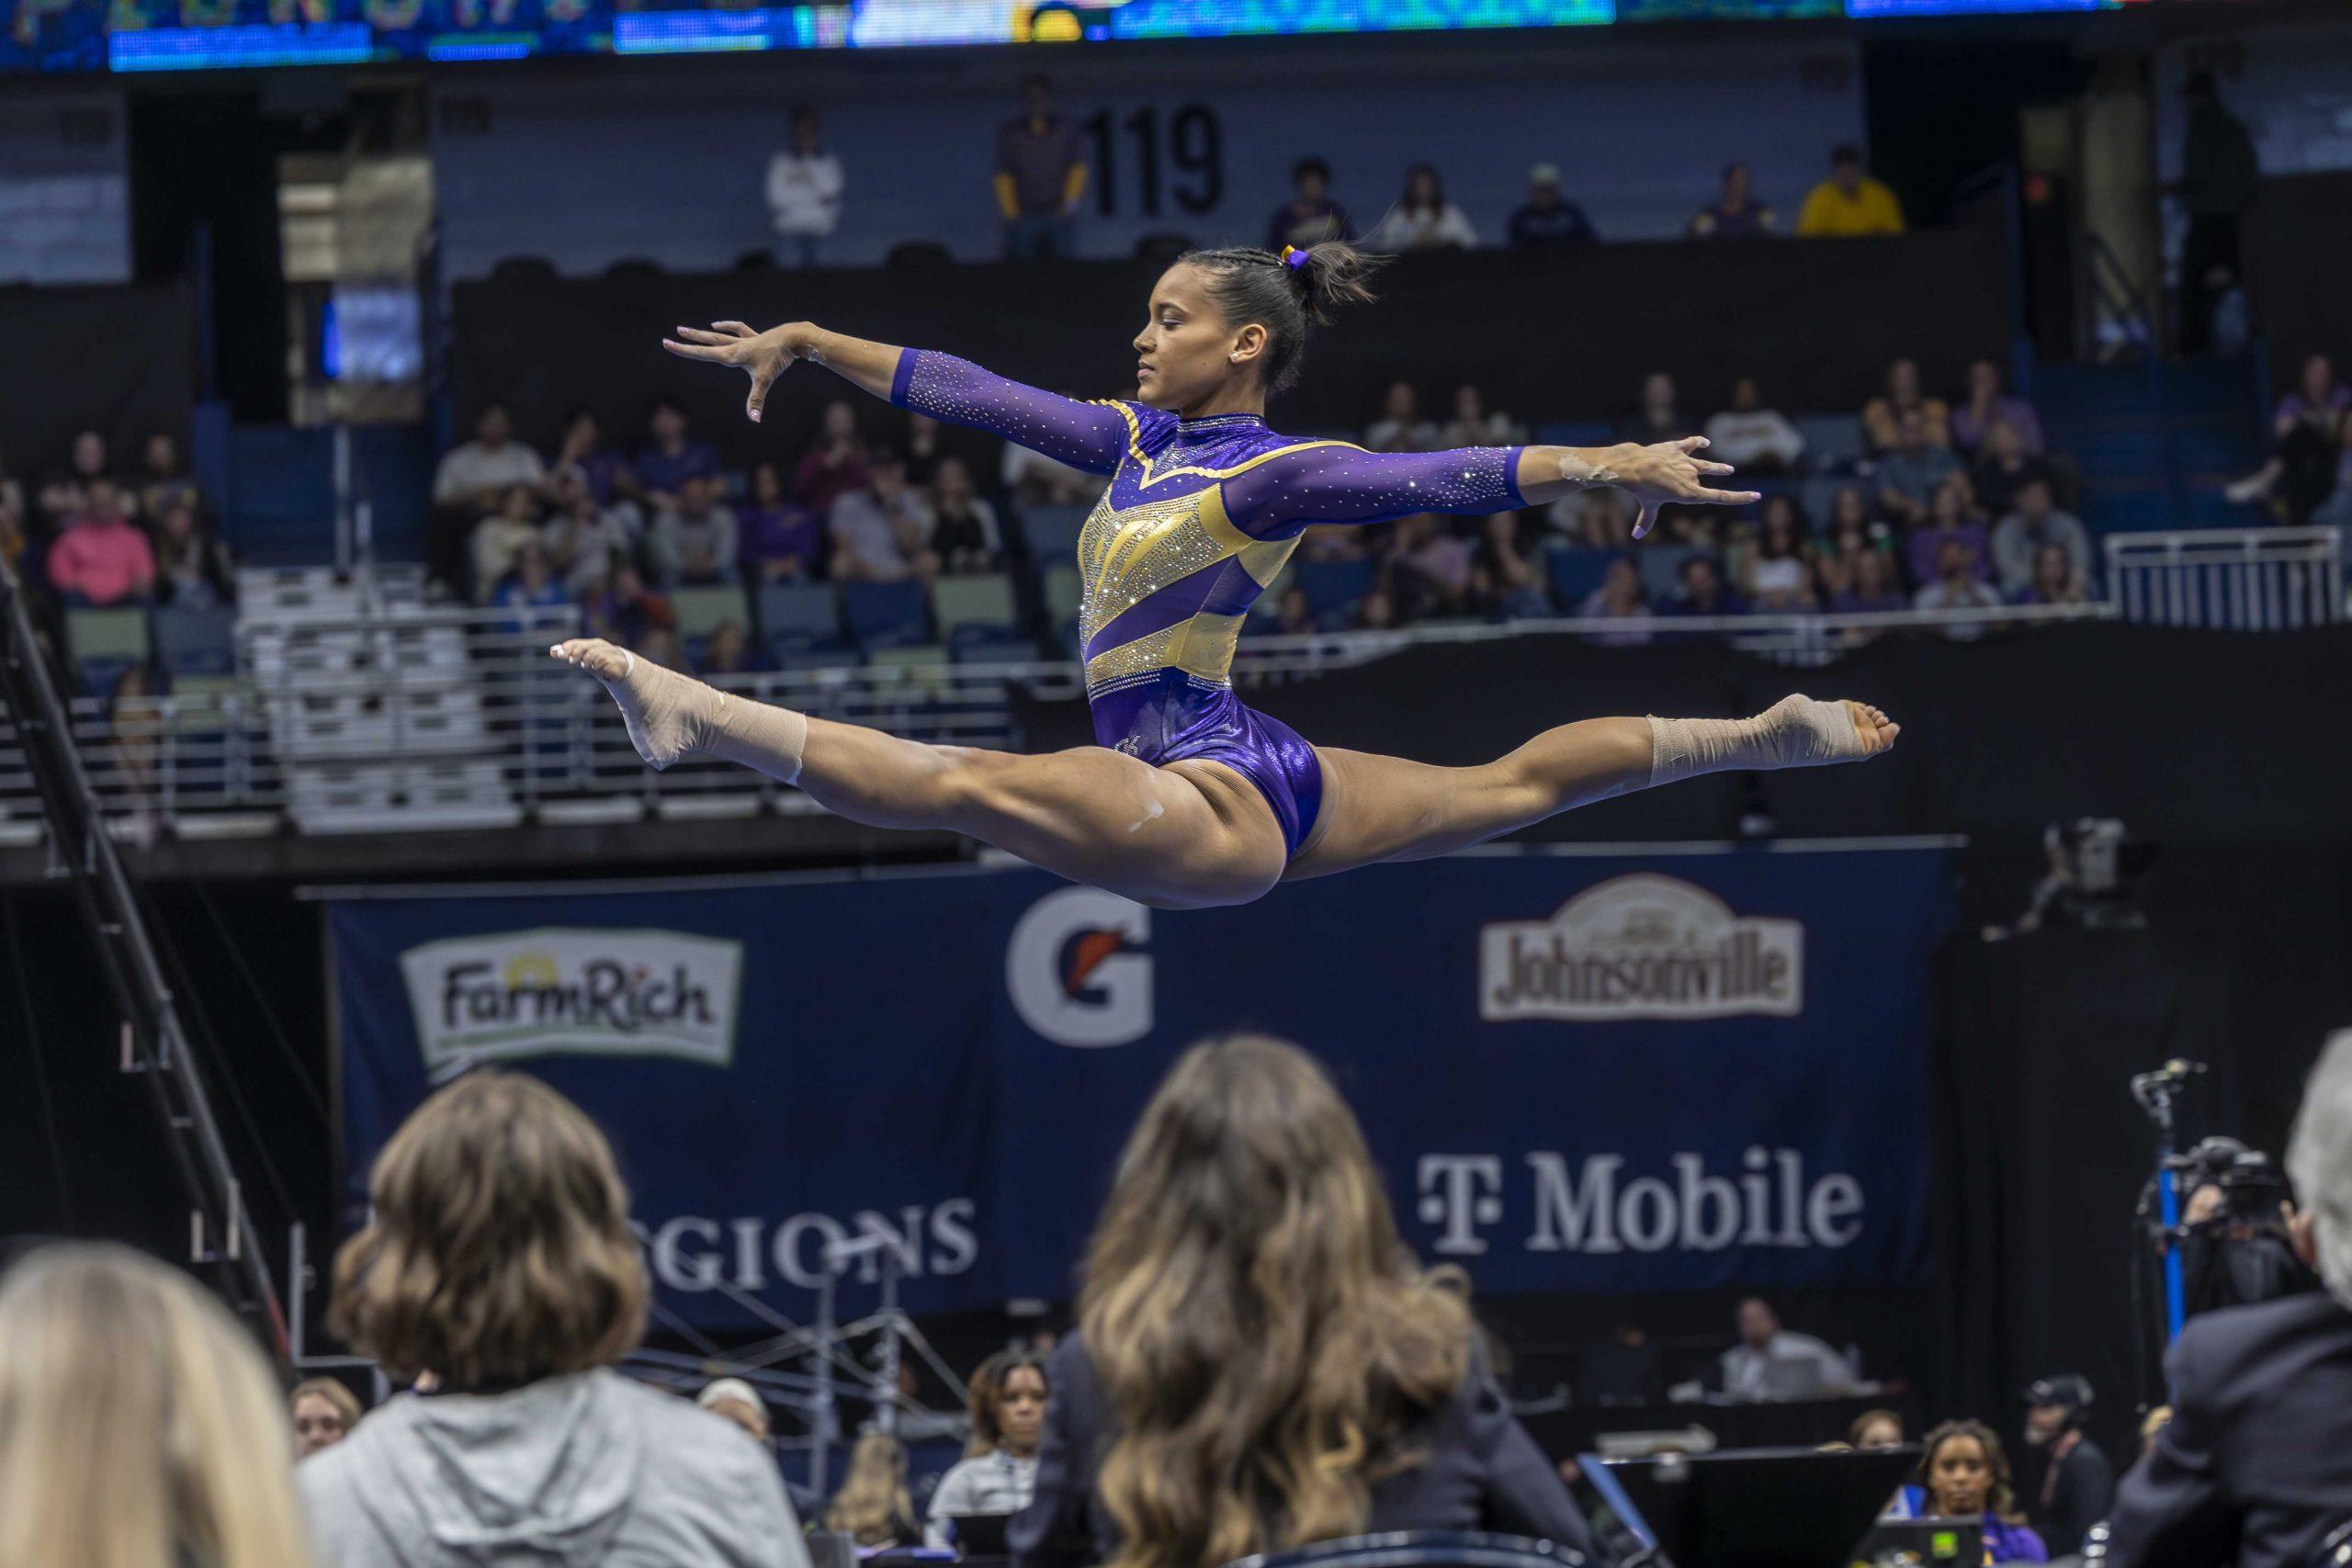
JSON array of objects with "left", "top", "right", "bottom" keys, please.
[{"left": 1479, "top": 874, "right": 1804, "bottom": 1022}]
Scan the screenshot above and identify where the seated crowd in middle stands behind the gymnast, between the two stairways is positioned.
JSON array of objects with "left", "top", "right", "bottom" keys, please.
[{"left": 433, "top": 360, "right": 2096, "bottom": 674}]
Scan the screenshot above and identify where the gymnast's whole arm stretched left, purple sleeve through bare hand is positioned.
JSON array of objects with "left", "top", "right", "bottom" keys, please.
[{"left": 661, "top": 322, "right": 1129, "bottom": 475}]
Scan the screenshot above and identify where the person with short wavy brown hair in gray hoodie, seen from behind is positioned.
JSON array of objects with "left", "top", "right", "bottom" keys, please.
[{"left": 297, "top": 1069, "right": 809, "bottom": 1568}]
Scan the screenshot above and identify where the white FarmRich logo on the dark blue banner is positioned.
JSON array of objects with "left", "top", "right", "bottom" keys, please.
[{"left": 400, "top": 929, "right": 743, "bottom": 1079}]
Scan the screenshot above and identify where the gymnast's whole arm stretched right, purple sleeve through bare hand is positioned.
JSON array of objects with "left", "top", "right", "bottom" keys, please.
[{"left": 1223, "top": 434, "right": 1757, "bottom": 538}]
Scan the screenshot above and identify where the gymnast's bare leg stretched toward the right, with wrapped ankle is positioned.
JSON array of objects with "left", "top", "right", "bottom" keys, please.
[{"left": 1284, "top": 696, "right": 1900, "bottom": 879}]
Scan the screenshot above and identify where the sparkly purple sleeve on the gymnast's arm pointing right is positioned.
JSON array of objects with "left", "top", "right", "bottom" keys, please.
[{"left": 1223, "top": 442, "right": 1526, "bottom": 538}]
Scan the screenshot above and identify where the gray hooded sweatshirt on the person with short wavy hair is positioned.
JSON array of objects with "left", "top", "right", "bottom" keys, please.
[{"left": 294, "top": 1368, "right": 809, "bottom": 1568}]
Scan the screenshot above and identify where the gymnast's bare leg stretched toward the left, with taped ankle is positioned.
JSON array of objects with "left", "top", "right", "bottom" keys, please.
[{"left": 553, "top": 637, "right": 1284, "bottom": 908}]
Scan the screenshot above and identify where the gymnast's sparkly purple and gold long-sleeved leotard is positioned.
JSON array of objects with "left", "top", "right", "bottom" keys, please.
[{"left": 889, "top": 348, "right": 1526, "bottom": 856}]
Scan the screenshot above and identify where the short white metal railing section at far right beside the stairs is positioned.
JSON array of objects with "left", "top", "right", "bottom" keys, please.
[{"left": 2108, "top": 529, "right": 2345, "bottom": 632}]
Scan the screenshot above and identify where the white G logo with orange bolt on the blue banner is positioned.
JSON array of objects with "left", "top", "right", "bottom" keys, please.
[{"left": 1004, "top": 888, "right": 1152, "bottom": 1046}]
